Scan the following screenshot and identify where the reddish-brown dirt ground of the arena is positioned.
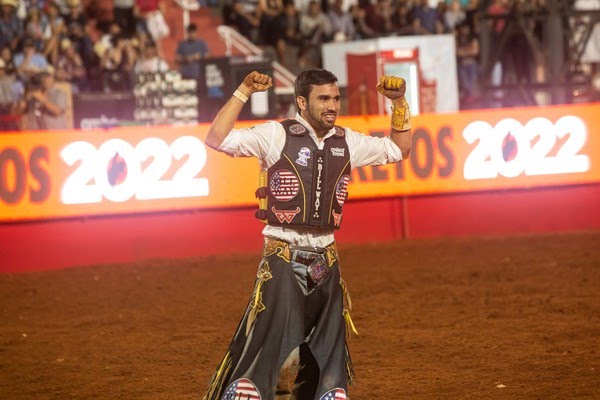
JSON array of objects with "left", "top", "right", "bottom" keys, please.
[{"left": 0, "top": 232, "right": 600, "bottom": 400}]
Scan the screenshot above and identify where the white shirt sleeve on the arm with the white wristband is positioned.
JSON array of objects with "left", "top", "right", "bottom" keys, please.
[{"left": 218, "top": 121, "right": 285, "bottom": 168}]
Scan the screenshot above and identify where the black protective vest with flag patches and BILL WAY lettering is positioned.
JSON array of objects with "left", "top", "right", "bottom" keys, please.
[{"left": 256, "top": 119, "right": 351, "bottom": 229}]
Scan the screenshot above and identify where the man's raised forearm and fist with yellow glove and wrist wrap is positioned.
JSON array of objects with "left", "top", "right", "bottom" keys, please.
[{"left": 377, "top": 76, "right": 412, "bottom": 159}]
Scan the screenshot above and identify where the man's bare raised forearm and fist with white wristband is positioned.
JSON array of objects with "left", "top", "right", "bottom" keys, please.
[{"left": 206, "top": 71, "right": 273, "bottom": 150}]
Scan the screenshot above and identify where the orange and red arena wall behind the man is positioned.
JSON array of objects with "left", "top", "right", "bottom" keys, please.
[{"left": 0, "top": 105, "right": 600, "bottom": 272}]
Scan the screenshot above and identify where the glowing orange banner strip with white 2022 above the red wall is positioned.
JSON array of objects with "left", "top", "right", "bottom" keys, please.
[{"left": 0, "top": 104, "right": 600, "bottom": 221}]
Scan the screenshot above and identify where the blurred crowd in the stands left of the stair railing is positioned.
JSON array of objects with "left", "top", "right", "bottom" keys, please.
[{"left": 0, "top": 0, "right": 209, "bottom": 130}]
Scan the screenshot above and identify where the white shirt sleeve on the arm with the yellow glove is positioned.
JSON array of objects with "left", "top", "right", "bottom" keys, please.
[{"left": 346, "top": 128, "right": 402, "bottom": 168}]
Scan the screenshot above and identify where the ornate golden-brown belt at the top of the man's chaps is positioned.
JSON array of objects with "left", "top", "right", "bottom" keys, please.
[{"left": 263, "top": 236, "right": 339, "bottom": 267}]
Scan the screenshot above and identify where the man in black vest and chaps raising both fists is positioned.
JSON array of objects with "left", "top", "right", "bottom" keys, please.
[{"left": 204, "top": 69, "right": 411, "bottom": 400}]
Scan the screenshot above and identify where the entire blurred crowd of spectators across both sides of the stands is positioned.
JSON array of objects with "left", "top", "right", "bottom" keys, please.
[{"left": 0, "top": 0, "right": 592, "bottom": 129}]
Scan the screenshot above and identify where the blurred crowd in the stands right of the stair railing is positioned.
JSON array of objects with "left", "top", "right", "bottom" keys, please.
[{"left": 222, "top": 0, "right": 592, "bottom": 105}]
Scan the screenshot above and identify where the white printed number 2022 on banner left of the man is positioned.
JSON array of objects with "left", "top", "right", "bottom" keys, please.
[{"left": 61, "top": 136, "right": 209, "bottom": 204}]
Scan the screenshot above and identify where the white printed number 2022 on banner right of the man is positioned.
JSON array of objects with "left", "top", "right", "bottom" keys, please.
[{"left": 463, "top": 115, "right": 590, "bottom": 179}]
